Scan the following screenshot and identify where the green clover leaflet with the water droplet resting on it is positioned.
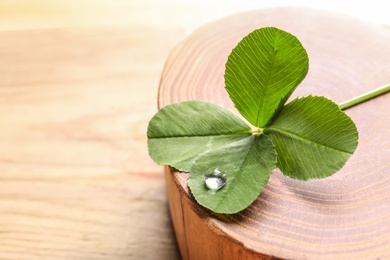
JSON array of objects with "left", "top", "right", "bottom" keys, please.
[{"left": 188, "top": 135, "right": 276, "bottom": 213}]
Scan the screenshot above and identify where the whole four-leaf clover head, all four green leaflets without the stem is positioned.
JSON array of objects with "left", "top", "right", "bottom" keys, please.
[{"left": 147, "top": 27, "right": 358, "bottom": 214}]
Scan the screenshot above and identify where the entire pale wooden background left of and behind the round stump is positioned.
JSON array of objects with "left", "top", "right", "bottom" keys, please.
[{"left": 0, "top": 0, "right": 390, "bottom": 260}]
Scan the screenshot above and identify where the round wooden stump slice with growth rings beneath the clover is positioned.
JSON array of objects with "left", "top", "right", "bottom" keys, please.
[{"left": 158, "top": 8, "right": 390, "bottom": 260}]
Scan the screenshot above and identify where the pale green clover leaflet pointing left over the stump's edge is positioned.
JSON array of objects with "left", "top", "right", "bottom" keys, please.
[{"left": 148, "top": 101, "right": 251, "bottom": 172}]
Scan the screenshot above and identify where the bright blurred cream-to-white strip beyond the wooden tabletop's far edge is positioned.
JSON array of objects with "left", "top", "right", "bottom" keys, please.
[{"left": 0, "top": 0, "right": 390, "bottom": 31}]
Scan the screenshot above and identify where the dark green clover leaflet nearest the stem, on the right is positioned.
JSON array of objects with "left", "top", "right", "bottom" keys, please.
[{"left": 264, "top": 96, "right": 358, "bottom": 180}]
